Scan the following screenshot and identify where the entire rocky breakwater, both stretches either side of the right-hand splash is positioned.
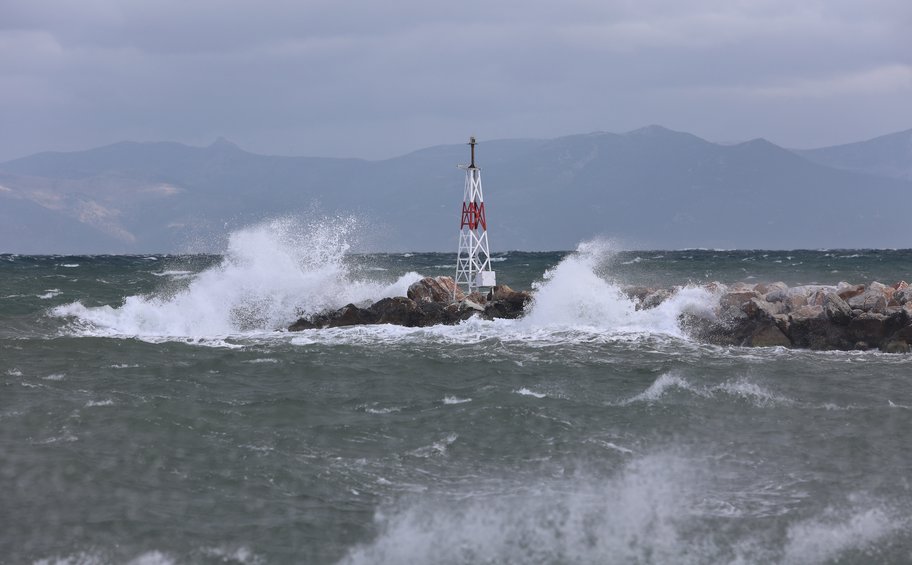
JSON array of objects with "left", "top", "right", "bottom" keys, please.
[{"left": 288, "top": 277, "right": 912, "bottom": 353}]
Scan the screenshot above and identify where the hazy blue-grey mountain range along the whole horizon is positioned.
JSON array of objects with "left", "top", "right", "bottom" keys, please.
[{"left": 0, "top": 126, "right": 912, "bottom": 253}]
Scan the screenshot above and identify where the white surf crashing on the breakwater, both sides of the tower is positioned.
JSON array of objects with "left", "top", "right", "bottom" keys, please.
[{"left": 50, "top": 223, "right": 711, "bottom": 346}]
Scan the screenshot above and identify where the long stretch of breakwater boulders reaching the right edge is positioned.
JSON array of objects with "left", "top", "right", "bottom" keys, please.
[{"left": 664, "top": 282, "right": 912, "bottom": 353}]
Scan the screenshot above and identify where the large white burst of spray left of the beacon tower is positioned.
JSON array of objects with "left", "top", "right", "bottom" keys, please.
[{"left": 51, "top": 218, "right": 419, "bottom": 338}]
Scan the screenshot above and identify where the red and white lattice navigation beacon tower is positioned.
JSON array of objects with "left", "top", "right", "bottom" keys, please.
[{"left": 456, "top": 136, "right": 497, "bottom": 294}]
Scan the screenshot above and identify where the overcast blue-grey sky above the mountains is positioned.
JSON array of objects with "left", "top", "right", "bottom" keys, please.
[{"left": 0, "top": 0, "right": 912, "bottom": 161}]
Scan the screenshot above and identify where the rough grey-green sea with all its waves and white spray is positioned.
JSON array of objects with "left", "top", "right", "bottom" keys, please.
[{"left": 0, "top": 220, "right": 912, "bottom": 565}]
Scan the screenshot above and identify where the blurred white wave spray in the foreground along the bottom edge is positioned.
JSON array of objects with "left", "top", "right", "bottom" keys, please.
[{"left": 340, "top": 454, "right": 909, "bottom": 565}]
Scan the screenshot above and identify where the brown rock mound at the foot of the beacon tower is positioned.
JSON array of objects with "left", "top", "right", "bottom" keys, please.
[{"left": 288, "top": 277, "right": 532, "bottom": 331}]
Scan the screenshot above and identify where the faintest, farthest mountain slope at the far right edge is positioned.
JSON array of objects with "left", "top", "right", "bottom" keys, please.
[{"left": 795, "top": 129, "right": 912, "bottom": 180}]
